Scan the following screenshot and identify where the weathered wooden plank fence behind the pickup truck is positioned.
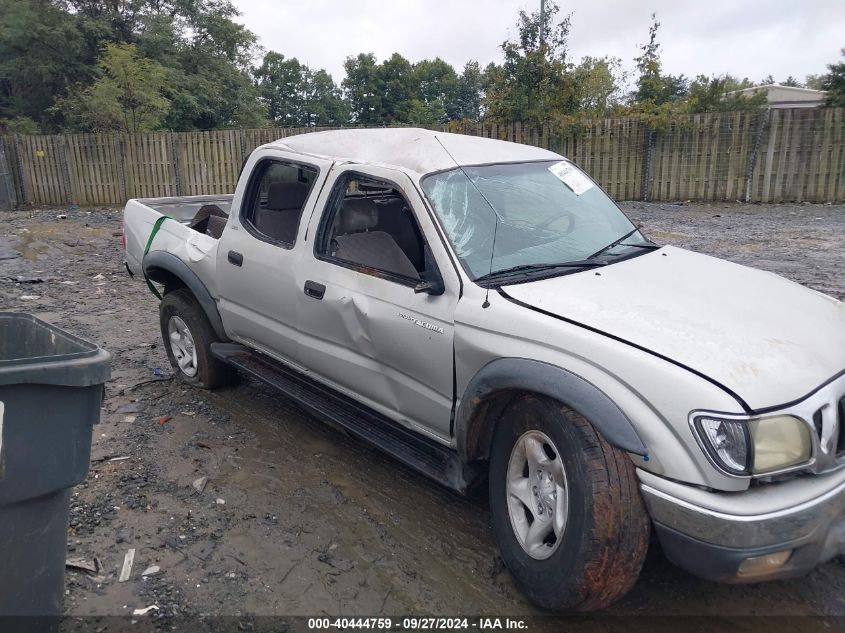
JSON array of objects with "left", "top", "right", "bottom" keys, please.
[{"left": 0, "top": 108, "right": 845, "bottom": 205}]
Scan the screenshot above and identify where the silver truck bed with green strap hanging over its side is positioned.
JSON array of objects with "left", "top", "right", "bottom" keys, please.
[{"left": 123, "top": 195, "right": 232, "bottom": 294}]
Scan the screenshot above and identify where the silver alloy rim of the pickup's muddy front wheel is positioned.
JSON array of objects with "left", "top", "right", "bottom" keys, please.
[{"left": 505, "top": 430, "right": 569, "bottom": 560}]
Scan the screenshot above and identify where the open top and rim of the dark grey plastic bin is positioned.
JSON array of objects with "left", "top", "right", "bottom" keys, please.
[{"left": 0, "top": 312, "right": 111, "bottom": 387}]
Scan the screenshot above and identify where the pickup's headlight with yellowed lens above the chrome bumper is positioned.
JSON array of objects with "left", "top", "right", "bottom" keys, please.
[{"left": 695, "top": 415, "right": 813, "bottom": 475}]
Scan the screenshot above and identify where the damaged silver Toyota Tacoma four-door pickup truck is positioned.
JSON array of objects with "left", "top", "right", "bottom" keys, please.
[{"left": 124, "top": 129, "right": 845, "bottom": 611}]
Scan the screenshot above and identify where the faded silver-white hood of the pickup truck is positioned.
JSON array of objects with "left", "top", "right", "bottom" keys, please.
[{"left": 503, "top": 246, "right": 845, "bottom": 410}]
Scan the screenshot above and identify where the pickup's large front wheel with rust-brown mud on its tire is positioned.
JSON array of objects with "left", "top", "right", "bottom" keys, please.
[{"left": 490, "top": 395, "right": 650, "bottom": 611}]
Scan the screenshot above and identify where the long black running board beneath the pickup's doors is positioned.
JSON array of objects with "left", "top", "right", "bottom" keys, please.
[{"left": 211, "top": 343, "right": 483, "bottom": 494}]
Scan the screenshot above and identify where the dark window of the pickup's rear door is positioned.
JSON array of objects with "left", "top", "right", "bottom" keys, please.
[{"left": 241, "top": 160, "right": 319, "bottom": 248}]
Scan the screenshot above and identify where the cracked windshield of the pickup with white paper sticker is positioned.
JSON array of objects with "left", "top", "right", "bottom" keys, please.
[{"left": 422, "top": 161, "right": 649, "bottom": 279}]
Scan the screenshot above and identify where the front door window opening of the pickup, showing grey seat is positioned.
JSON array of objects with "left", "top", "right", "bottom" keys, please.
[{"left": 316, "top": 175, "right": 425, "bottom": 285}]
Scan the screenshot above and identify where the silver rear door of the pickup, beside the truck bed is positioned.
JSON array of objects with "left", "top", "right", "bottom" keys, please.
[{"left": 216, "top": 150, "right": 331, "bottom": 364}]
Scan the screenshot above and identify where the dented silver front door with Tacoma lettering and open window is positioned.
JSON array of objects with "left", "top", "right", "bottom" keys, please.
[{"left": 297, "top": 165, "right": 459, "bottom": 441}]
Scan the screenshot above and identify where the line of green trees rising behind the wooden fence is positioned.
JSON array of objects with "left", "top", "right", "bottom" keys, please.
[{"left": 0, "top": 0, "right": 845, "bottom": 133}]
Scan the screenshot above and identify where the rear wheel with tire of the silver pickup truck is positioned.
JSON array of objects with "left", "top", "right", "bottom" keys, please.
[{"left": 159, "top": 288, "right": 237, "bottom": 389}]
